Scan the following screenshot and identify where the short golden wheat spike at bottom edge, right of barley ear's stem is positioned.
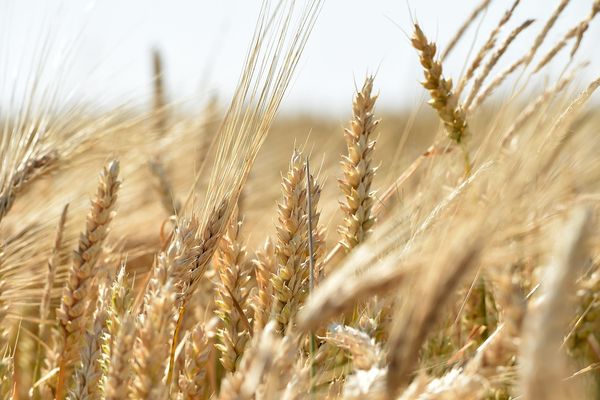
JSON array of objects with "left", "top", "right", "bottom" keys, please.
[{"left": 178, "top": 323, "right": 210, "bottom": 400}]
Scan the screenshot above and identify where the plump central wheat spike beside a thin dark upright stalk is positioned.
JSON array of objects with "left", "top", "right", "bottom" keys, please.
[{"left": 271, "top": 151, "right": 320, "bottom": 331}]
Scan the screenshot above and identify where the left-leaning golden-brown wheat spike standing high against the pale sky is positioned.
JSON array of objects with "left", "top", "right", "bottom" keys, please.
[{"left": 411, "top": 24, "right": 468, "bottom": 144}]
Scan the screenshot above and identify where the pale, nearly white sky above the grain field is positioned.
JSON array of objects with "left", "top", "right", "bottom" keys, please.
[{"left": 0, "top": 0, "right": 600, "bottom": 114}]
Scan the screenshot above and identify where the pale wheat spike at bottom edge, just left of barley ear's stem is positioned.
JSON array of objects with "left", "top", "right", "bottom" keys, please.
[{"left": 130, "top": 277, "right": 175, "bottom": 400}]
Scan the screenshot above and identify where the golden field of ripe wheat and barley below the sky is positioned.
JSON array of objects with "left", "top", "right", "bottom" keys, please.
[{"left": 0, "top": 0, "right": 600, "bottom": 400}]
